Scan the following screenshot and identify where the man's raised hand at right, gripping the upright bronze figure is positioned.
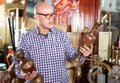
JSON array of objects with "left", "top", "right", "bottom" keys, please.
[{"left": 79, "top": 44, "right": 93, "bottom": 57}]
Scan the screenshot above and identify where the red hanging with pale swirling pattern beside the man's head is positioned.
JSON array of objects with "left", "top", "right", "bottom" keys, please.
[{"left": 53, "top": 0, "right": 80, "bottom": 25}]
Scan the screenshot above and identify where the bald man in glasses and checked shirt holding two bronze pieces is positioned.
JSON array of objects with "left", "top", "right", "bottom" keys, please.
[{"left": 15, "top": 2, "right": 93, "bottom": 83}]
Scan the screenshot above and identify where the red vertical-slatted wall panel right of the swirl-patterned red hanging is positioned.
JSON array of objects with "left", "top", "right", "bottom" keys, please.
[{"left": 79, "top": 0, "right": 100, "bottom": 29}]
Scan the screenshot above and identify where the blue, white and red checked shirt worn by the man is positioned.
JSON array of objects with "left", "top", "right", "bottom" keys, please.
[{"left": 15, "top": 28, "right": 84, "bottom": 83}]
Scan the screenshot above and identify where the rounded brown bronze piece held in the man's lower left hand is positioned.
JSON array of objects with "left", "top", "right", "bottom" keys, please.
[{"left": 15, "top": 50, "right": 43, "bottom": 83}]
